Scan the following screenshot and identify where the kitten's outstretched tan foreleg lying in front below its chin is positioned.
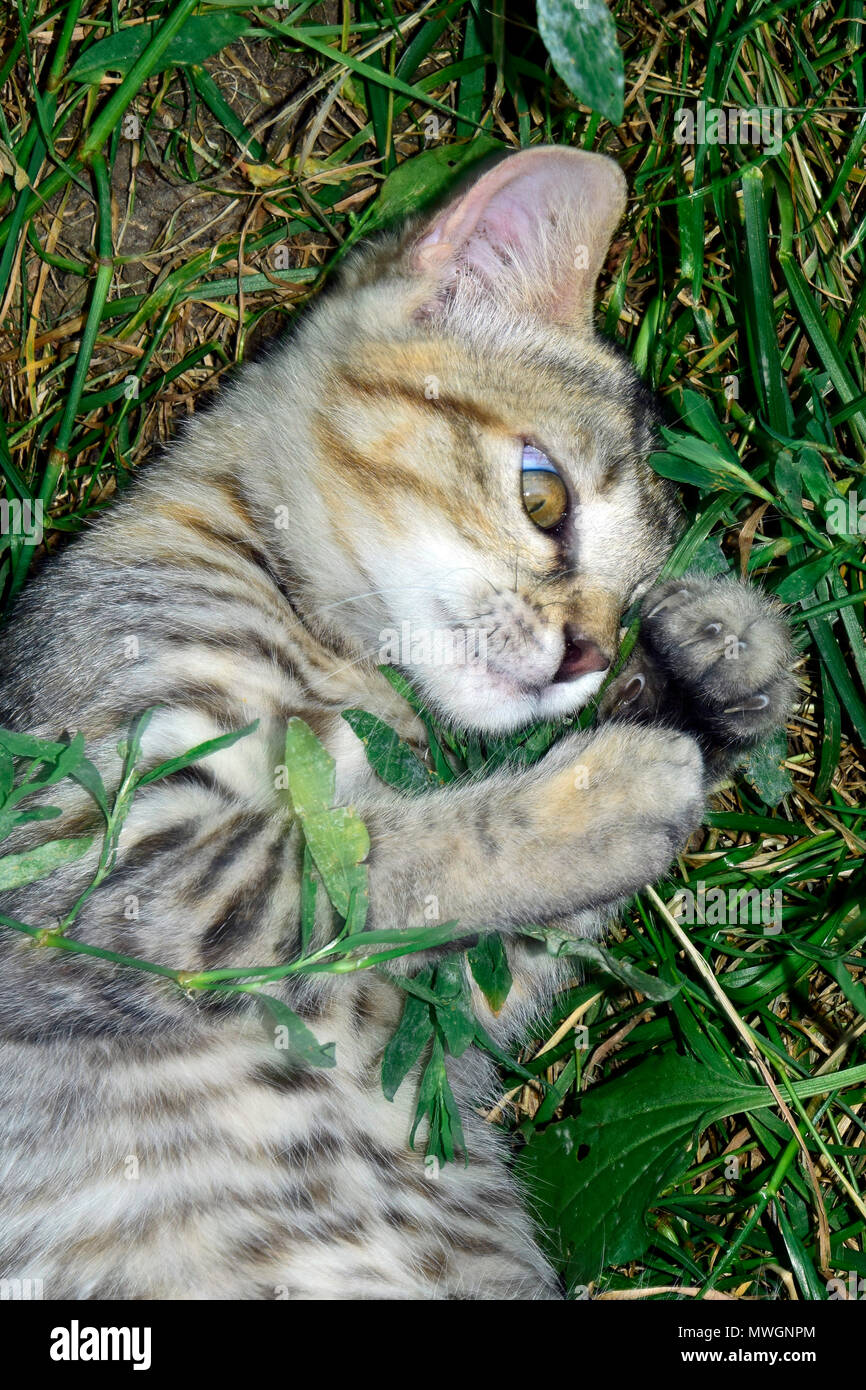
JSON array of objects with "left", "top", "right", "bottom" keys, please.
[{"left": 357, "top": 723, "right": 706, "bottom": 934}]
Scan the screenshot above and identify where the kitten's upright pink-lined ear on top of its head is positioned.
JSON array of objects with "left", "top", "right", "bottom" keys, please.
[{"left": 409, "top": 146, "right": 626, "bottom": 328}]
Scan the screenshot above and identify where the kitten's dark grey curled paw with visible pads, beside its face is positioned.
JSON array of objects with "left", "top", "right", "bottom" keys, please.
[{"left": 605, "top": 575, "right": 795, "bottom": 772}]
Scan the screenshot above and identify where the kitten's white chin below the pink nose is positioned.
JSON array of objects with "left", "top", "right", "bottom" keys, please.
[{"left": 417, "top": 671, "right": 607, "bottom": 734}]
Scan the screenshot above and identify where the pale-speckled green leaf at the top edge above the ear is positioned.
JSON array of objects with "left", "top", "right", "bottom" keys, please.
[{"left": 538, "top": 0, "right": 626, "bottom": 125}]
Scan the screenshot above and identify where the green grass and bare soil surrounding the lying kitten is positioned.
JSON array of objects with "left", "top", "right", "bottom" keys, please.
[{"left": 0, "top": 0, "right": 866, "bottom": 1298}]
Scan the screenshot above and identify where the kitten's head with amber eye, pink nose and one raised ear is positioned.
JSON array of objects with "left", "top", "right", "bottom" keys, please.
[{"left": 268, "top": 147, "right": 677, "bottom": 731}]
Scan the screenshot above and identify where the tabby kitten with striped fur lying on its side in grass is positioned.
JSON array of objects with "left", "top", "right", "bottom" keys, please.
[{"left": 0, "top": 147, "right": 791, "bottom": 1298}]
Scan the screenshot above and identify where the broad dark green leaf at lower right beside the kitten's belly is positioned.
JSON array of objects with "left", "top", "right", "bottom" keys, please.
[{"left": 517, "top": 1052, "right": 763, "bottom": 1287}]
